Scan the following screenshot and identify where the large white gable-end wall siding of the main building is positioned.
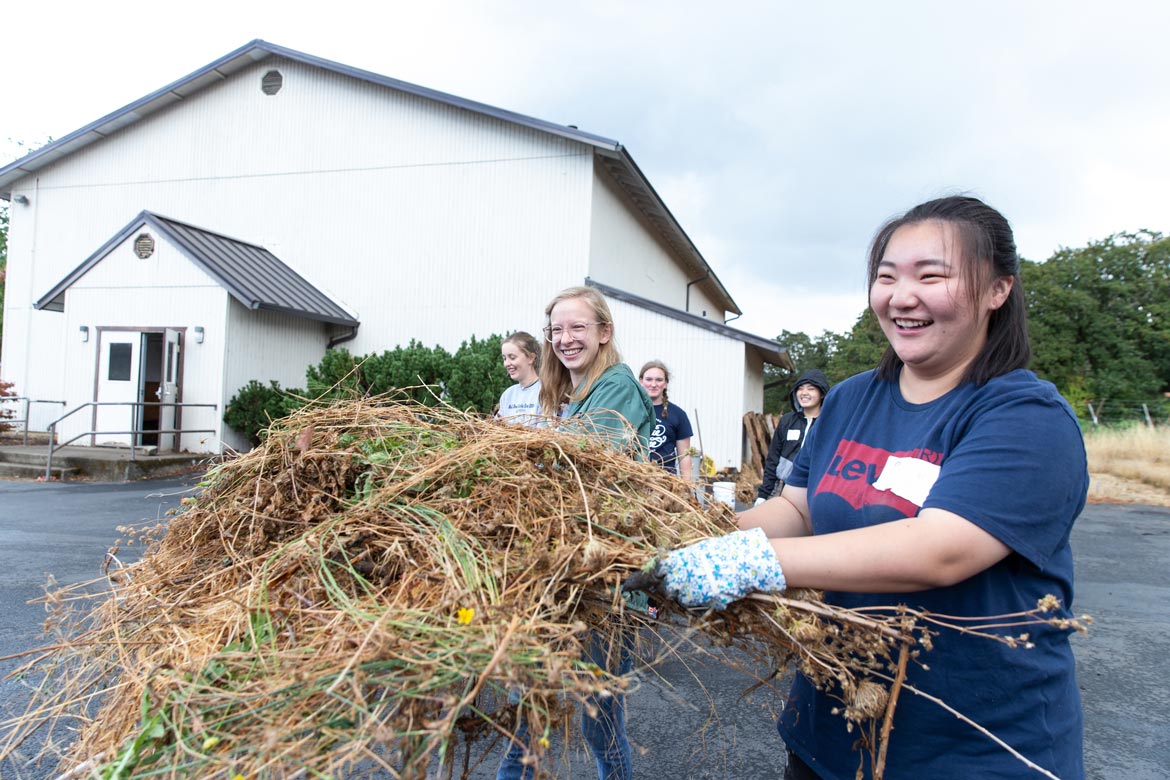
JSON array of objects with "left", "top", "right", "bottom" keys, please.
[{"left": 5, "top": 54, "right": 592, "bottom": 413}]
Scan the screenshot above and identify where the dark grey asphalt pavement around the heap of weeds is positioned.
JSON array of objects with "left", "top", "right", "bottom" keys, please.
[{"left": 0, "top": 476, "right": 1170, "bottom": 780}]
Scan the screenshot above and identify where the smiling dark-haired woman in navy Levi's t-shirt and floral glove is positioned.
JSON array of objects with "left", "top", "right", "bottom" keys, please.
[{"left": 660, "top": 196, "right": 1088, "bottom": 780}]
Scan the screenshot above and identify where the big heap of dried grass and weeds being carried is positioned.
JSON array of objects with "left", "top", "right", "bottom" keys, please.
[{"left": 0, "top": 399, "right": 1085, "bottom": 780}]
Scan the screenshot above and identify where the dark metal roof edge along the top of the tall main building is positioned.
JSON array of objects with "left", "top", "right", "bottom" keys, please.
[{"left": 0, "top": 39, "right": 743, "bottom": 315}]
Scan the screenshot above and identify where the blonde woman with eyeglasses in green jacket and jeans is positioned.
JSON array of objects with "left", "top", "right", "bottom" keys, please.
[{"left": 496, "top": 287, "right": 654, "bottom": 780}]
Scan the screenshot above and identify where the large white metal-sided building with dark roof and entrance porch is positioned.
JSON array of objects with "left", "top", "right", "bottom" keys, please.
[{"left": 0, "top": 41, "right": 787, "bottom": 467}]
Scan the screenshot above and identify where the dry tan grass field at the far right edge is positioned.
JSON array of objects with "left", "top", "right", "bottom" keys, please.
[{"left": 1085, "top": 426, "right": 1170, "bottom": 506}]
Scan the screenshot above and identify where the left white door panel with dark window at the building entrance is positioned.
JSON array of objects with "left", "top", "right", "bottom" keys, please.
[{"left": 92, "top": 331, "right": 142, "bottom": 446}]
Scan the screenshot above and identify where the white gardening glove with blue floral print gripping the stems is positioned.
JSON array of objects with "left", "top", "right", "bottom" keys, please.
[{"left": 624, "top": 529, "right": 785, "bottom": 609}]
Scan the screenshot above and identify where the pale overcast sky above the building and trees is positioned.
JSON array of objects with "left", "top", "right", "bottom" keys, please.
[{"left": 0, "top": 0, "right": 1170, "bottom": 337}]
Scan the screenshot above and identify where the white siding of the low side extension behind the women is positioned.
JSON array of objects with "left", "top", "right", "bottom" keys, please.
[{"left": 608, "top": 299, "right": 748, "bottom": 469}]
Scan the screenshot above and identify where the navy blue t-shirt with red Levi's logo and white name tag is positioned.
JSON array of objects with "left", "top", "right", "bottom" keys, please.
[{"left": 779, "top": 371, "right": 1088, "bottom": 780}]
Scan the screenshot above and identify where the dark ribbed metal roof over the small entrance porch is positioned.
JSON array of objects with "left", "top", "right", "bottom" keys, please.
[{"left": 33, "top": 212, "right": 358, "bottom": 326}]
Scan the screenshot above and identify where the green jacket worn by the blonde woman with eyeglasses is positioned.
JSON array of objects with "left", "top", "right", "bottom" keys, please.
[{"left": 565, "top": 363, "right": 654, "bottom": 461}]
